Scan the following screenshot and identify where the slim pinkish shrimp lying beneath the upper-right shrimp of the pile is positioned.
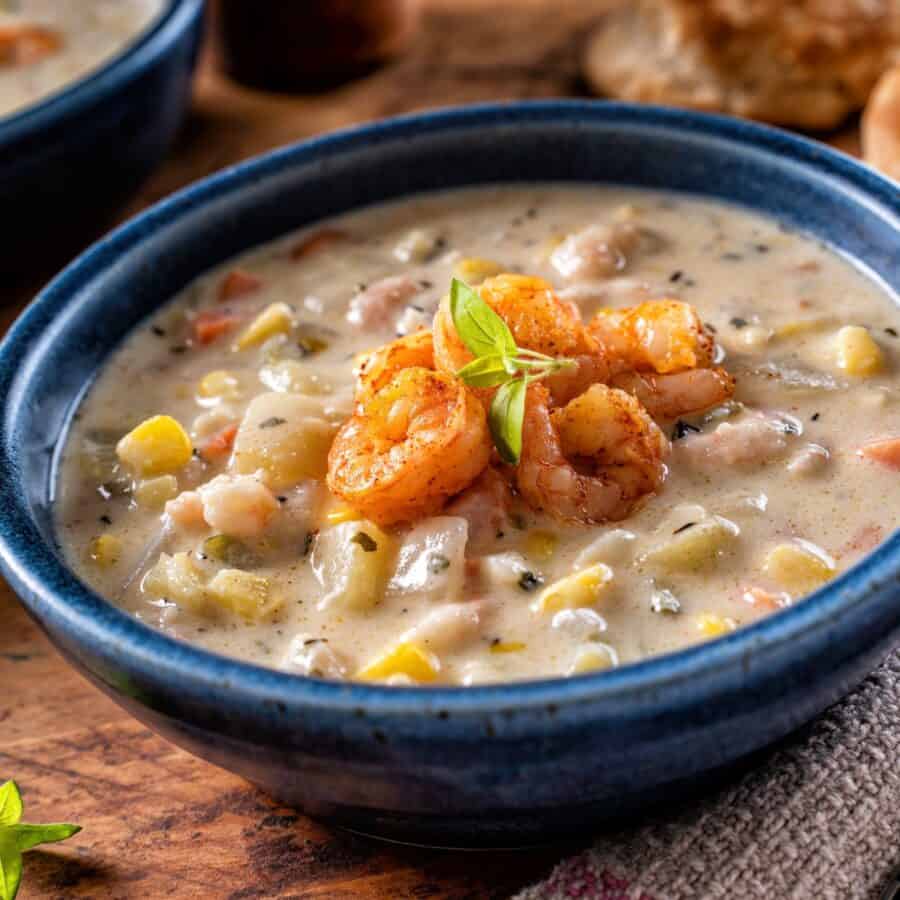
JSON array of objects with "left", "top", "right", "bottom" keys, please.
[{"left": 610, "top": 368, "right": 734, "bottom": 419}]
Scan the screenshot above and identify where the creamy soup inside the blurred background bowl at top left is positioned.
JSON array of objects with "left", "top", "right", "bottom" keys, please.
[{"left": 0, "top": 0, "right": 166, "bottom": 116}]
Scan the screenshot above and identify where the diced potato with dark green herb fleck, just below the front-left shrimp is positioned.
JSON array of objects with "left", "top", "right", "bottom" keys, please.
[{"left": 312, "top": 519, "right": 396, "bottom": 611}]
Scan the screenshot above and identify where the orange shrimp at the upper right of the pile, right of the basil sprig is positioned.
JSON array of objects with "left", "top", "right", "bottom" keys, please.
[{"left": 588, "top": 298, "right": 715, "bottom": 375}]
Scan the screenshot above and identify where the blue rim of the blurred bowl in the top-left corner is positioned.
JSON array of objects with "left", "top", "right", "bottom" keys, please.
[{"left": 0, "top": 0, "right": 204, "bottom": 147}]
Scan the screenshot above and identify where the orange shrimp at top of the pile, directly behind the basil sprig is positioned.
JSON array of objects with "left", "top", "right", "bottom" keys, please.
[{"left": 434, "top": 274, "right": 609, "bottom": 404}]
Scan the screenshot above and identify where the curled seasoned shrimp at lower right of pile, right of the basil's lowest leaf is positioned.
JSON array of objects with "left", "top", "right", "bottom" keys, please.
[{"left": 516, "top": 384, "right": 669, "bottom": 524}]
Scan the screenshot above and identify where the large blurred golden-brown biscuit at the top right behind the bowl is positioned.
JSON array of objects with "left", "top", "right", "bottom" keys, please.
[{"left": 584, "top": 0, "right": 900, "bottom": 129}]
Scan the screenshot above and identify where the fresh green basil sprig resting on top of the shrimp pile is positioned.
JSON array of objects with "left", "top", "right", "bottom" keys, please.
[{"left": 450, "top": 278, "right": 577, "bottom": 465}]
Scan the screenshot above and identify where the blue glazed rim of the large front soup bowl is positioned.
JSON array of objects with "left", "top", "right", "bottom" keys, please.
[{"left": 0, "top": 100, "right": 900, "bottom": 717}]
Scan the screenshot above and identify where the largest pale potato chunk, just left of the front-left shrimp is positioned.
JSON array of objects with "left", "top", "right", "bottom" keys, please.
[{"left": 231, "top": 392, "right": 335, "bottom": 490}]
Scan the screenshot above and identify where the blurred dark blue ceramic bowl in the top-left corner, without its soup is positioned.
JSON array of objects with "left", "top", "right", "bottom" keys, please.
[{"left": 0, "top": 0, "right": 203, "bottom": 274}]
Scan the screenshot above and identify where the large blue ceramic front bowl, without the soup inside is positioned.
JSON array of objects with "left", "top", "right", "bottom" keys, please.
[{"left": 0, "top": 102, "right": 900, "bottom": 846}]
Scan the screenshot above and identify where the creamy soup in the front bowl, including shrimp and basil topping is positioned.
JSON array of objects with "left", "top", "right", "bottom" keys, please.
[{"left": 58, "top": 186, "right": 900, "bottom": 684}]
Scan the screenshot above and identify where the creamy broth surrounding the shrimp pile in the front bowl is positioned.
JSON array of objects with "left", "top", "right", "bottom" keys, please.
[{"left": 58, "top": 185, "right": 900, "bottom": 684}]
